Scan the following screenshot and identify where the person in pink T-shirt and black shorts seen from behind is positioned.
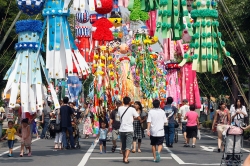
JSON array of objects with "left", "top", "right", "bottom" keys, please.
[{"left": 184, "top": 105, "right": 200, "bottom": 148}]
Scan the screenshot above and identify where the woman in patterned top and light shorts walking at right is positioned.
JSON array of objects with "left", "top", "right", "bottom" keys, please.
[{"left": 212, "top": 101, "right": 230, "bottom": 153}]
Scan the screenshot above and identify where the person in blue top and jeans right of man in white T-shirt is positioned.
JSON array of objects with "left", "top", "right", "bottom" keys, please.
[{"left": 164, "top": 97, "right": 178, "bottom": 148}]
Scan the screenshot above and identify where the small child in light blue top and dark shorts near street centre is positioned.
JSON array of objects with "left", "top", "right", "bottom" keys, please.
[{"left": 96, "top": 122, "right": 108, "bottom": 154}]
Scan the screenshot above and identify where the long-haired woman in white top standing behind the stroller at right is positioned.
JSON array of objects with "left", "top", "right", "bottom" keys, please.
[{"left": 230, "top": 99, "right": 247, "bottom": 126}]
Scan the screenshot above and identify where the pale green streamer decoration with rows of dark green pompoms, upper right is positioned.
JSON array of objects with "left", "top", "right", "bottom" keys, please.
[{"left": 180, "top": 0, "right": 236, "bottom": 73}]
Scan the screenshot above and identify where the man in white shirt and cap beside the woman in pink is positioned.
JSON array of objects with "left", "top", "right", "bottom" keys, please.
[{"left": 179, "top": 99, "right": 189, "bottom": 144}]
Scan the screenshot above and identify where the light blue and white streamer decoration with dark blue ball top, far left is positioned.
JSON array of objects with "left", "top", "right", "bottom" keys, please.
[{"left": 4, "top": 20, "right": 60, "bottom": 113}]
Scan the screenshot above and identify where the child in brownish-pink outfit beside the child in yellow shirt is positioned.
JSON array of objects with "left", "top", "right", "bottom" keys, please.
[{"left": 20, "top": 119, "right": 31, "bottom": 157}]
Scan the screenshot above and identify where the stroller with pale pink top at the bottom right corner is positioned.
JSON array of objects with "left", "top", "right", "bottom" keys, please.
[{"left": 221, "top": 126, "right": 244, "bottom": 166}]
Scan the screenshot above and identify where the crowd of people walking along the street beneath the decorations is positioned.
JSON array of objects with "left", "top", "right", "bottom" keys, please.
[{"left": 1, "top": 97, "right": 250, "bottom": 163}]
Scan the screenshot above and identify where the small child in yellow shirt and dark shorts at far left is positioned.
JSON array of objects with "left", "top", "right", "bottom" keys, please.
[{"left": 1, "top": 121, "right": 16, "bottom": 157}]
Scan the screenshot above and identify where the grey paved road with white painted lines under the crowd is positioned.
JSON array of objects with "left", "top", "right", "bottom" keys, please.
[{"left": 0, "top": 128, "right": 250, "bottom": 166}]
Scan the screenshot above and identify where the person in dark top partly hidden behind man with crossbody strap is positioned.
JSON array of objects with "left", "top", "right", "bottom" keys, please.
[{"left": 109, "top": 100, "right": 122, "bottom": 152}]
